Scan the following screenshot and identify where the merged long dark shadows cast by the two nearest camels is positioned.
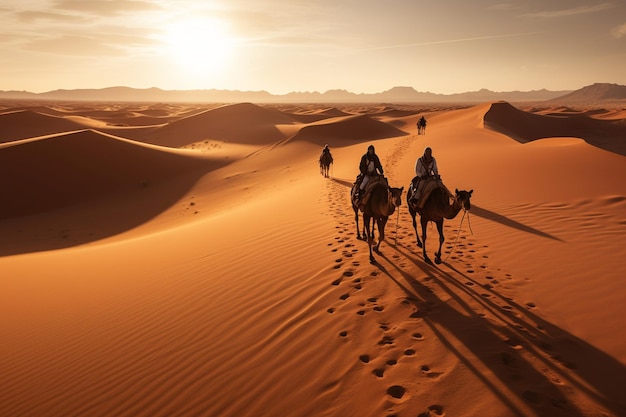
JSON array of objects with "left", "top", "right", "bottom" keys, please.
[{"left": 378, "top": 248, "right": 626, "bottom": 417}]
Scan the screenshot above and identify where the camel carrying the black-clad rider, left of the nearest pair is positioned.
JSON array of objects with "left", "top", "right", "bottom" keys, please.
[{"left": 350, "top": 180, "right": 404, "bottom": 263}]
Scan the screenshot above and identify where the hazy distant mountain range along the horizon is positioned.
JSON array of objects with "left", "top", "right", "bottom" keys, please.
[{"left": 0, "top": 83, "right": 626, "bottom": 103}]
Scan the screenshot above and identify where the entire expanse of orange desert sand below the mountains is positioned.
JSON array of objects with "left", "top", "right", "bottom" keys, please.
[{"left": 0, "top": 98, "right": 626, "bottom": 417}]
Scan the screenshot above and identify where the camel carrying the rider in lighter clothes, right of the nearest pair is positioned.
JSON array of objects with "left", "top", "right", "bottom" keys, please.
[{"left": 406, "top": 180, "right": 474, "bottom": 264}]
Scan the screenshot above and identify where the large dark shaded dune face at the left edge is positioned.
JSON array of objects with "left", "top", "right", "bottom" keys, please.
[{"left": 0, "top": 130, "right": 224, "bottom": 255}]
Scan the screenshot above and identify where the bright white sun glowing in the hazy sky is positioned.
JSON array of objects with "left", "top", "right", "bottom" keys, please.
[{"left": 162, "top": 19, "right": 235, "bottom": 74}]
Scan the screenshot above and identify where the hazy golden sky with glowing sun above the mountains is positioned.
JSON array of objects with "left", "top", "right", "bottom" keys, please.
[{"left": 0, "top": 0, "right": 626, "bottom": 94}]
